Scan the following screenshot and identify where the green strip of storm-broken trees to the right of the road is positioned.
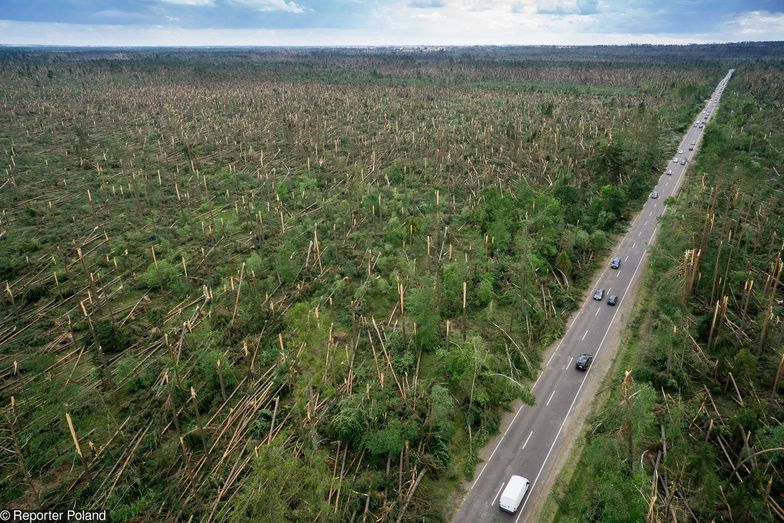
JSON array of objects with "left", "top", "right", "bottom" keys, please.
[{"left": 556, "top": 62, "right": 784, "bottom": 522}]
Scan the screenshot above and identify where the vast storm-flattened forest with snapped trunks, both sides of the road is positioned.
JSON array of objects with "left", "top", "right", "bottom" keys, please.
[{"left": 0, "top": 44, "right": 784, "bottom": 522}]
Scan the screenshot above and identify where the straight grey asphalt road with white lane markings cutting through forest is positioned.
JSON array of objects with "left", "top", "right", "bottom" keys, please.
[{"left": 454, "top": 69, "right": 734, "bottom": 523}]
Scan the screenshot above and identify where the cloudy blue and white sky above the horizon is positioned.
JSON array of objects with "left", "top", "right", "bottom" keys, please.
[{"left": 0, "top": 0, "right": 784, "bottom": 46}]
